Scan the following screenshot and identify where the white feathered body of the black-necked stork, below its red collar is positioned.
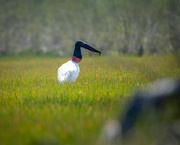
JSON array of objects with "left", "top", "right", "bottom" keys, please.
[{"left": 57, "top": 60, "right": 80, "bottom": 83}]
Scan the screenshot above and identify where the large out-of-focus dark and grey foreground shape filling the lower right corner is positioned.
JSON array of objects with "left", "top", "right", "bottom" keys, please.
[{"left": 102, "top": 79, "right": 180, "bottom": 145}]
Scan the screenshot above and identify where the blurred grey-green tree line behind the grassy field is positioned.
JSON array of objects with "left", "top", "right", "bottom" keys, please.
[{"left": 0, "top": 0, "right": 180, "bottom": 56}]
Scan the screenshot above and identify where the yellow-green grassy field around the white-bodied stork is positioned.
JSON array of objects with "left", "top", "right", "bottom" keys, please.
[{"left": 0, "top": 56, "right": 180, "bottom": 145}]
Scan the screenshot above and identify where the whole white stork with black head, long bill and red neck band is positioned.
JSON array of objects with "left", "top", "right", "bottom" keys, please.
[{"left": 57, "top": 40, "right": 101, "bottom": 84}]
